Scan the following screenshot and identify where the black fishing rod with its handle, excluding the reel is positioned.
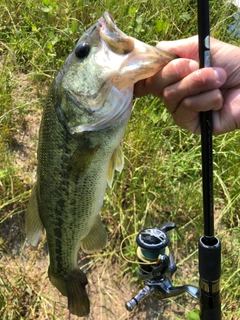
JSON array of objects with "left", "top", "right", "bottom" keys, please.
[{"left": 198, "top": 0, "right": 221, "bottom": 320}]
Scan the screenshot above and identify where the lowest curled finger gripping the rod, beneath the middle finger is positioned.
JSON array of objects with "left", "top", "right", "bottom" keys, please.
[{"left": 172, "top": 89, "right": 224, "bottom": 133}]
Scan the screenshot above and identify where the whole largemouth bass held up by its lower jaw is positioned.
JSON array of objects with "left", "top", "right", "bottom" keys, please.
[{"left": 25, "top": 12, "right": 176, "bottom": 317}]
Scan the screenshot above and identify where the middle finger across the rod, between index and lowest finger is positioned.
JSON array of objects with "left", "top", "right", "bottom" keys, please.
[{"left": 163, "top": 68, "right": 227, "bottom": 113}]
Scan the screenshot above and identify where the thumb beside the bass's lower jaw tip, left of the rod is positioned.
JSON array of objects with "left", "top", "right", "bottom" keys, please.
[{"left": 157, "top": 36, "right": 198, "bottom": 61}]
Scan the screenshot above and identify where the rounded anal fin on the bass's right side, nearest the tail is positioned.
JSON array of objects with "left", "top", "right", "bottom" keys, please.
[{"left": 80, "top": 215, "right": 108, "bottom": 253}]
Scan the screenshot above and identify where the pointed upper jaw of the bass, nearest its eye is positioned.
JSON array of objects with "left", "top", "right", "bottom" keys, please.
[{"left": 98, "top": 12, "right": 134, "bottom": 55}]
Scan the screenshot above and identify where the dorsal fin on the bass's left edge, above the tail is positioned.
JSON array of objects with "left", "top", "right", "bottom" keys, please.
[{"left": 25, "top": 185, "right": 44, "bottom": 246}]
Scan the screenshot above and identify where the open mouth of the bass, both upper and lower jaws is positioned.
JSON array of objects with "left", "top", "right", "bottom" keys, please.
[{"left": 98, "top": 12, "right": 177, "bottom": 90}]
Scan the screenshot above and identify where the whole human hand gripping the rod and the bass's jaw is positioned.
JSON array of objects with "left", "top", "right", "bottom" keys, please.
[{"left": 134, "top": 36, "right": 240, "bottom": 134}]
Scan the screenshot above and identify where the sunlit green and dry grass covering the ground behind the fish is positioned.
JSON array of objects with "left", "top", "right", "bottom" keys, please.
[{"left": 0, "top": 0, "right": 240, "bottom": 320}]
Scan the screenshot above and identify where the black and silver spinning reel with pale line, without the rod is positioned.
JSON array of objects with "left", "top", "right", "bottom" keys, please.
[{"left": 125, "top": 222, "right": 199, "bottom": 311}]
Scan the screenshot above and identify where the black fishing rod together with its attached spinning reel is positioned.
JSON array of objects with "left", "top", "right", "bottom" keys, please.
[{"left": 125, "top": 0, "right": 221, "bottom": 320}]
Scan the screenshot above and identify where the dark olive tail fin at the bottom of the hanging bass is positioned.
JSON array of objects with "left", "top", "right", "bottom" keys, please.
[{"left": 48, "top": 266, "right": 90, "bottom": 317}]
